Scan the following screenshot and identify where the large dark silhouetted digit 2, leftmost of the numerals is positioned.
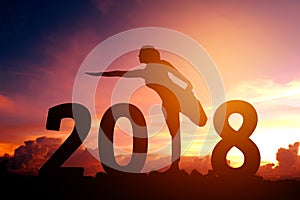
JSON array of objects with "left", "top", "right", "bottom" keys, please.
[{"left": 39, "top": 103, "right": 91, "bottom": 175}]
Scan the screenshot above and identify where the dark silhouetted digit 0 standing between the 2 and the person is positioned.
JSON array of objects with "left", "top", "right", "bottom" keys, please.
[{"left": 98, "top": 103, "right": 148, "bottom": 174}]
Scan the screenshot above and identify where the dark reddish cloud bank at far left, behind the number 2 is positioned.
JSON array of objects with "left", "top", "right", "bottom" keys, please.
[{"left": 0, "top": 137, "right": 103, "bottom": 176}]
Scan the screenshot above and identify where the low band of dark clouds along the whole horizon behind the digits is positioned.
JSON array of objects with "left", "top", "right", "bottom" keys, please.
[{"left": 0, "top": 137, "right": 300, "bottom": 180}]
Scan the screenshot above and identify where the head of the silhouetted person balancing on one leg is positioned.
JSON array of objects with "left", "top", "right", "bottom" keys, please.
[{"left": 139, "top": 45, "right": 160, "bottom": 63}]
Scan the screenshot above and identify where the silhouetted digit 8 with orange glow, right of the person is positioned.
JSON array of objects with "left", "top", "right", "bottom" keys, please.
[{"left": 211, "top": 100, "right": 260, "bottom": 176}]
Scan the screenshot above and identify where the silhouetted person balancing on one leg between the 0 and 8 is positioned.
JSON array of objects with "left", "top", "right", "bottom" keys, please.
[{"left": 86, "top": 46, "right": 207, "bottom": 169}]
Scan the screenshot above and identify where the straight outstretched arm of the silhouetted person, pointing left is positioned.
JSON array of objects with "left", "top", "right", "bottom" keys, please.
[{"left": 85, "top": 69, "right": 143, "bottom": 78}]
